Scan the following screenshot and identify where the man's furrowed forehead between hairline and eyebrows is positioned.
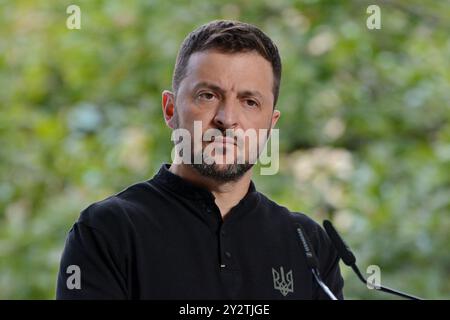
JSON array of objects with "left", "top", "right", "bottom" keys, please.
[{"left": 183, "top": 50, "right": 274, "bottom": 99}]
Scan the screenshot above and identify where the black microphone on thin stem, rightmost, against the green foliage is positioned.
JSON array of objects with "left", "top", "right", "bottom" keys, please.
[{"left": 323, "top": 220, "right": 422, "bottom": 300}]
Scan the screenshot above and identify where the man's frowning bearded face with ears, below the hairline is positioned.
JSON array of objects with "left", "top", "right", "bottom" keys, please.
[{"left": 163, "top": 50, "right": 280, "bottom": 181}]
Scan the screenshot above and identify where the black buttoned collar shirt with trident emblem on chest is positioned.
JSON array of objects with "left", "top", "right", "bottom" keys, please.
[{"left": 56, "top": 164, "right": 343, "bottom": 299}]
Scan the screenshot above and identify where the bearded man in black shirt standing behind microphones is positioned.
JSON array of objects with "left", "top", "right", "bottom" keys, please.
[{"left": 57, "top": 21, "right": 343, "bottom": 299}]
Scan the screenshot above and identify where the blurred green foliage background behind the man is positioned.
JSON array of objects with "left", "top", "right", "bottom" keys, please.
[{"left": 0, "top": 0, "right": 450, "bottom": 299}]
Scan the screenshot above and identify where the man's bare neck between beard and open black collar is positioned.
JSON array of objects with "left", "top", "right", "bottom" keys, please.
[{"left": 169, "top": 164, "right": 252, "bottom": 218}]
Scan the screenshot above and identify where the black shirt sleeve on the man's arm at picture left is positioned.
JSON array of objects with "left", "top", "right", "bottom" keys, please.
[{"left": 56, "top": 221, "right": 127, "bottom": 300}]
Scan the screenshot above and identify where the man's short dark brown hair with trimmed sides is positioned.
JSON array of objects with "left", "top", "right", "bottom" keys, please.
[{"left": 172, "top": 20, "right": 281, "bottom": 106}]
